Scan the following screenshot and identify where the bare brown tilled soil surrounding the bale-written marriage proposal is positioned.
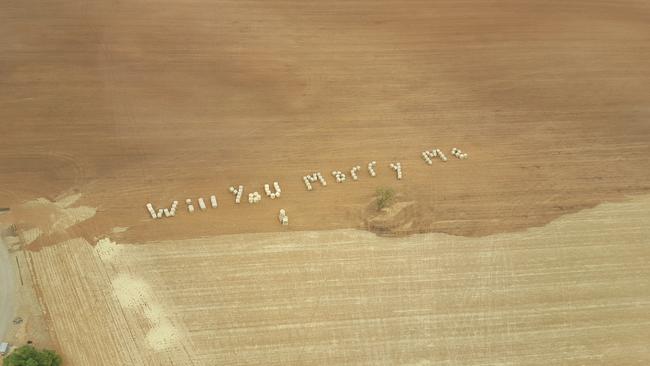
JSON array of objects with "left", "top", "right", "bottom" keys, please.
[{"left": 0, "top": 0, "right": 650, "bottom": 247}]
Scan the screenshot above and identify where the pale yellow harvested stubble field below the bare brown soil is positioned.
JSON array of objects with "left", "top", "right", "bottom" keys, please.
[{"left": 22, "top": 197, "right": 650, "bottom": 365}]
